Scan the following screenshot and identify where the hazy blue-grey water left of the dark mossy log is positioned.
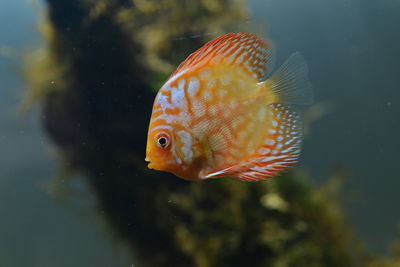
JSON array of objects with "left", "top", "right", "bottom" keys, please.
[{"left": 0, "top": 0, "right": 131, "bottom": 267}]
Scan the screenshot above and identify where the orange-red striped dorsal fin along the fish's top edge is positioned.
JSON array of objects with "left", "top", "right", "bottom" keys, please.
[{"left": 171, "top": 32, "right": 274, "bottom": 81}]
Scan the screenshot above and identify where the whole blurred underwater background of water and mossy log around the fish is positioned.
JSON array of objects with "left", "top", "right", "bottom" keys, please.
[{"left": 0, "top": 0, "right": 400, "bottom": 266}]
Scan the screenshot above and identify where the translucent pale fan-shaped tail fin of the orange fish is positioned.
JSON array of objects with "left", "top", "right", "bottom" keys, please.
[{"left": 268, "top": 52, "right": 314, "bottom": 105}]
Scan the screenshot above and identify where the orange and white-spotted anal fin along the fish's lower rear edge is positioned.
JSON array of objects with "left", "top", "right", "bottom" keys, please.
[{"left": 205, "top": 104, "right": 303, "bottom": 181}]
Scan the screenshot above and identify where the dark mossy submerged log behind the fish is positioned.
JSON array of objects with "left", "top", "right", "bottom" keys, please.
[{"left": 21, "top": 0, "right": 390, "bottom": 266}]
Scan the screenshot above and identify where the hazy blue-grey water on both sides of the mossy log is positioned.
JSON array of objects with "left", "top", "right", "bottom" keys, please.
[{"left": 0, "top": 0, "right": 400, "bottom": 266}]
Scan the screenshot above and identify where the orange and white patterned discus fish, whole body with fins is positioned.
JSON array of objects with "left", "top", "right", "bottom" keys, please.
[{"left": 146, "top": 33, "right": 313, "bottom": 181}]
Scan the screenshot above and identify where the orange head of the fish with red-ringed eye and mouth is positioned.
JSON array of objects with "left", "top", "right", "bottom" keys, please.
[{"left": 145, "top": 125, "right": 201, "bottom": 180}]
